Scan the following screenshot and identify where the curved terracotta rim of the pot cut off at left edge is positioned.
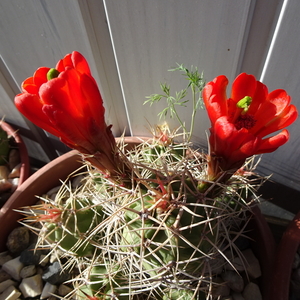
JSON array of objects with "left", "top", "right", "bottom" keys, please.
[{"left": 0, "top": 121, "right": 30, "bottom": 186}]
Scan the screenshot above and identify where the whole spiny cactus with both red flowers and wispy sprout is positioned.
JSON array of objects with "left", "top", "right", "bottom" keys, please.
[{"left": 4, "top": 52, "right": 297, "bottom": 299}]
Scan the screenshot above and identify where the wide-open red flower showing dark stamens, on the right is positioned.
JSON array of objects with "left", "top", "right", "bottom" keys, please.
[{"left": 203, "top": 73, "right": 298, "bottom": 180}]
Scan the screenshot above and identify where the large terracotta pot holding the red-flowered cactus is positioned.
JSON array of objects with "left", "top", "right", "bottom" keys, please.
[{"left": 0, "top": 138, "right": 275, "bottom": 300}]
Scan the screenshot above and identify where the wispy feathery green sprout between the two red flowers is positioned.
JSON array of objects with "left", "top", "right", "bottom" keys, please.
[{"left": 144, "top": 64, "right": 205, "bottom": 141}]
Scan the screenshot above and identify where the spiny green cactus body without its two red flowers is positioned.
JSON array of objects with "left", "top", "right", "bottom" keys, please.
[{"left": 24, "top": 141, "right": 256, "bottom": 300}]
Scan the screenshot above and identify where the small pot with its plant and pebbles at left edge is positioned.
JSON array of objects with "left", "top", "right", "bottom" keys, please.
[{"left": 0, "top": 120, "right": 30, "bottom": 207}]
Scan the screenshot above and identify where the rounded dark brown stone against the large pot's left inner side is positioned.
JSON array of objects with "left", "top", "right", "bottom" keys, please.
[{"left": 6, "top": 226, "right": 29, "bottom": 253}]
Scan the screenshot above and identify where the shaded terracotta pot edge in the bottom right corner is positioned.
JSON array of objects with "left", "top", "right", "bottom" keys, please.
[{"left": 271, "top": 212, "right": 300, "bottom": 300}]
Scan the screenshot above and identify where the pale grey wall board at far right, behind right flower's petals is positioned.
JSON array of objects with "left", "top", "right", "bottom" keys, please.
[{"left": 254, "top": 0, "right": 300, "bottom": 189}]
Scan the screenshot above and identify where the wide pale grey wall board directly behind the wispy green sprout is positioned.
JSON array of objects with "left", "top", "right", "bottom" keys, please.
[{"left": 104, "top": 0, "right": 253, "bottom": 144}]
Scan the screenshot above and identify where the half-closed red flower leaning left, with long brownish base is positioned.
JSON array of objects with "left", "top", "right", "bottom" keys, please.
[{"left": 15, "top": 51, "right": 127, "bottom": 174}]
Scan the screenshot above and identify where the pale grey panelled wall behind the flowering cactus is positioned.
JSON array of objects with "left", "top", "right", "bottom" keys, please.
[{"left": 0, "top": 0, "right": 300, "bottom": 189}]
